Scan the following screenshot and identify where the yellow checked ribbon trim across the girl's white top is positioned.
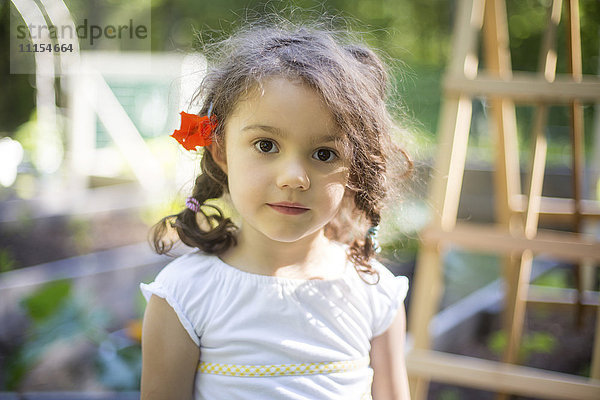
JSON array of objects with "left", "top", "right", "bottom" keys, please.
[{"left": 198, "top": 357, "right": 369, "bottom": 377}]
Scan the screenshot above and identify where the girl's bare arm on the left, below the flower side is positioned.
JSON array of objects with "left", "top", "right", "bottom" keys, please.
[{"left": 141, "top": 295, "right": 200, "bottom": 400}]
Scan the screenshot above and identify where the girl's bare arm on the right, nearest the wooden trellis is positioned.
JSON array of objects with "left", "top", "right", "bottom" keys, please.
[{"left": 370, "top": 307, "right": 410, "bottom": 400}]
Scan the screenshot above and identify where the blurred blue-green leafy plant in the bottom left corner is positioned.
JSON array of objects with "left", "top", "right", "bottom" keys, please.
[{"left": 0, "top": 280, "right": 141, "bottom": 391}]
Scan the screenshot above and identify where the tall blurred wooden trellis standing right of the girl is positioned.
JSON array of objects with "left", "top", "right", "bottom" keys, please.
[{"left": 407, "top": 0, "right": 600, "bottom": 400}]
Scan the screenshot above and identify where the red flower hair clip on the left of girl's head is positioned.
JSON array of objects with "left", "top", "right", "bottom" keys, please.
[{"left": 171, "top": 104, "right": 217, "bottom": 150}]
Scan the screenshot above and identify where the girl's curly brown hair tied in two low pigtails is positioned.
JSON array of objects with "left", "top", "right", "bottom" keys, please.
[{"left": 152, "top": 18, "right": 413, "bottom": 277}]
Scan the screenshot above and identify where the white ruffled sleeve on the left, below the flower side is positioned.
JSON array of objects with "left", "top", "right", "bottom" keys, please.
[{"left": 140, "top": 253, "right": 212, "bottom": 346}]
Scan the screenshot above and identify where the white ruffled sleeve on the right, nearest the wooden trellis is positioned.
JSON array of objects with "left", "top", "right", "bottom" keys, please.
[{"left": 371, "top": 261, "right": 408, "bottom": 337}]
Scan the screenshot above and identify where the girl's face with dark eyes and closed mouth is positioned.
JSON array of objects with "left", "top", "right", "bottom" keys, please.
[{"left": 215, "top": 77, "right": 349, "bottom": 242}]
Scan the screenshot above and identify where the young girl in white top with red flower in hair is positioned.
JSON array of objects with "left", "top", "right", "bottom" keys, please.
[{"left": 141, "top": 20, "right": 411, "bottom": 400}]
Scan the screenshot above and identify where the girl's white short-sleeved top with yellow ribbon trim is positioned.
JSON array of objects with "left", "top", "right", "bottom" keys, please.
[{"left": 140, "top": 248, "right": 408, "bottom": 400}]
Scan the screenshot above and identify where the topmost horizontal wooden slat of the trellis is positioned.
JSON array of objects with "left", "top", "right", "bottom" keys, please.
[{"left": 444, "top": 72, "right": 600, "bottom": 103}]
